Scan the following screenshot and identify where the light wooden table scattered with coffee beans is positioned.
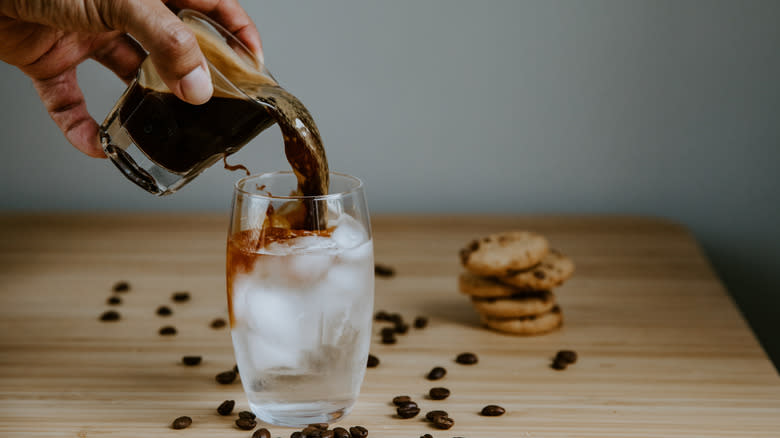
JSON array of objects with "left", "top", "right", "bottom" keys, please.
[{"left": 0, "top": 215, "right": 780, "bottom": 438}]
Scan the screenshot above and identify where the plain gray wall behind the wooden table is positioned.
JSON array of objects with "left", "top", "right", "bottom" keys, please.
[{"left": 0, "top": 0, "right": 780, "bottom": 364}]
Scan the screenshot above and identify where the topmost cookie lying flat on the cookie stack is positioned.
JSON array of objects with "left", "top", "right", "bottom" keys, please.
[{"left": 460, "top": 231, "right": 549, "bottom": 276}]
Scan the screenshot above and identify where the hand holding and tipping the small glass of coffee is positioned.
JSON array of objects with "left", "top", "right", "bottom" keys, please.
[{"left": 0, "top": 0, "right": 262, "bottom": 157}]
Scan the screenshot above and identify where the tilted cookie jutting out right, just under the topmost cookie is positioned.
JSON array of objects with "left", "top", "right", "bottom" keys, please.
[{"left": 498, "top": 250, "right": 574, "bottom": 290}]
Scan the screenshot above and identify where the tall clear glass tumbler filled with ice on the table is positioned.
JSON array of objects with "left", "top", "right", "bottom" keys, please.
[{"left": 227, "top": 172, "right": 374, "bottom": 426}]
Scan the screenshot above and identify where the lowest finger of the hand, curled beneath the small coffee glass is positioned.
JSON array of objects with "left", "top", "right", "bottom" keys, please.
[{"left": 33, "top": 67, "right": 105, "bottom": 158}]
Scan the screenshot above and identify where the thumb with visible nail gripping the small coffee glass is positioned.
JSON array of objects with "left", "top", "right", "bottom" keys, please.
[{"left": 109, "top": 0, "right": 214, "bottom": 105}]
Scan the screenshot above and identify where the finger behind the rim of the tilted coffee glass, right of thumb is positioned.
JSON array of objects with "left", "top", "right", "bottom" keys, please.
[{"left": 168, "top": 0, "right": 263, "bottom": 62}]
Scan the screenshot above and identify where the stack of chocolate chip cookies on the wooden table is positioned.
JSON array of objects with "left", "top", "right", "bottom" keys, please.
[{"left": 459, "top": 231, "right": 574, "bottom": 335}]
